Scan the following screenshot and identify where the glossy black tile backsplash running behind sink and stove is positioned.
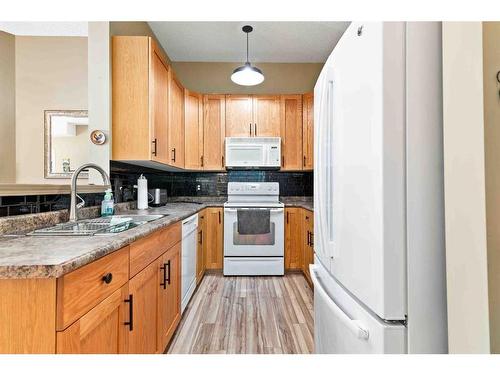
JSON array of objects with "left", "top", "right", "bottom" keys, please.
[{"left": 0, "top": 162, "right": 313, "bottom": 217}]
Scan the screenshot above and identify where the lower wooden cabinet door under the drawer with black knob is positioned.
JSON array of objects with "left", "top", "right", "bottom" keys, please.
[{"left": 56, "top": 284, "right": 130, "bottom": 354}]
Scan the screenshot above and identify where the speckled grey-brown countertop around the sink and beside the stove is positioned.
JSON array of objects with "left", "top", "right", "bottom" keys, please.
[{"left": 0, "top": 197, "right": 312, "bottom": 279}]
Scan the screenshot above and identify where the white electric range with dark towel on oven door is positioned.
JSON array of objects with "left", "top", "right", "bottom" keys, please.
[{"left": 224, "top": 182, "right": 285, "bottom": 275}]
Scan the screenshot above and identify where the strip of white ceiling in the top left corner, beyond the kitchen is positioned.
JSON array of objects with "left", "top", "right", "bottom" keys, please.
[{"left": 0, "top": 22, "right": 88, "bottom": 36}]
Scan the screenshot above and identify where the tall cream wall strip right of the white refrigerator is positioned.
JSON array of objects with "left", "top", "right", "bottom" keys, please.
[{"left": 444, "top": 22, "right": 490, "bottom": 353}]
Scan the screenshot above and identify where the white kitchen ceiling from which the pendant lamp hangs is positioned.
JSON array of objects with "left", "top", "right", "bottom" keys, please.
[{"left": 149, "top": 22, "right": 349, "bottom": 63}]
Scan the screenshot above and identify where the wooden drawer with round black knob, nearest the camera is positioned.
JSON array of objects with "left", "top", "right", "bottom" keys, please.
[{"left": 56, "top": 246, "right": 129, "bottom": 331}]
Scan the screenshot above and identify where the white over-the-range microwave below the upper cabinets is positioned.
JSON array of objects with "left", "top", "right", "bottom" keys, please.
[{"left": 226, "top": 137, "right": 281, "bottom": 169}]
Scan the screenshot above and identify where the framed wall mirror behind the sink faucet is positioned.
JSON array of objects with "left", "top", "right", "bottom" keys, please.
[{"left": 44, "top": 110, "right": 89, "bottom": 178}]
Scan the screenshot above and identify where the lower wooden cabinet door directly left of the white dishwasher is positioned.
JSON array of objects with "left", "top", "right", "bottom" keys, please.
[{"left": 156, "top": 242, "right": 181, "bottom": 353}]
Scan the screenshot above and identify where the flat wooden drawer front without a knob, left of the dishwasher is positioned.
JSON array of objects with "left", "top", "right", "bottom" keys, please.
[{"left": 130, "top": 222, "right": 181, "bottom": 278}]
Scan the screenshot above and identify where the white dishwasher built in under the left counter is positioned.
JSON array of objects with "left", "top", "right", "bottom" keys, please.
[{"left": 181, "top": 214, "right": 198, "bottom": 312}]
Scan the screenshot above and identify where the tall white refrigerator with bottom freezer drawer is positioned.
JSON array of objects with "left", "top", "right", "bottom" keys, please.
[{"left": 311, "top": 22, "right": 447, "bottom": 353}]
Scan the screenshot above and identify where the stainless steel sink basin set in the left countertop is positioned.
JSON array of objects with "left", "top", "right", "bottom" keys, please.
[{"left": 28, "top": 215, "right": 166, "bottom": 236}]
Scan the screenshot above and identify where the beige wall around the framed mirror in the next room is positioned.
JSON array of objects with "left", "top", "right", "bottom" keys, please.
[{"left": 12, "top": 36, "right": 90, "bottom": 184}]
